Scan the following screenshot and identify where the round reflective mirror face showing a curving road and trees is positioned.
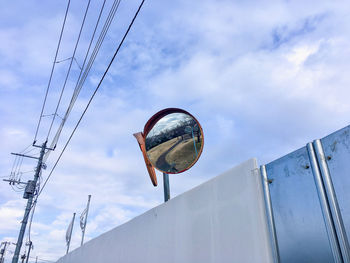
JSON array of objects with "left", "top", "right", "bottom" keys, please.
[{"left": 145, "top": 113, "right": 203, "bottom": 174}]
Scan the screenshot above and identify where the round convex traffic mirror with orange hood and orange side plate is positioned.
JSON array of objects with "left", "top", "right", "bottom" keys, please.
[{"left": 134, "top": 108, "right": 204, "bottom": 186}]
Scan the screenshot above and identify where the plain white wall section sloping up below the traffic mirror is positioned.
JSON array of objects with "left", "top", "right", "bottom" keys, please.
[{"left": 58, "top": 159, "right": 272, "bottom": 263}]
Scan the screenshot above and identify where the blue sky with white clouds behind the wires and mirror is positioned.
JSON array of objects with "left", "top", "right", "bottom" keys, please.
[{"left": 0, "top": 0, "right": 350, "bottom": 262}]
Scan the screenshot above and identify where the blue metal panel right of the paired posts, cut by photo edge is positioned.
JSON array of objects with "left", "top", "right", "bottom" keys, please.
[{"left": 321, "top": 126, "right": 350, "bottom": 253}]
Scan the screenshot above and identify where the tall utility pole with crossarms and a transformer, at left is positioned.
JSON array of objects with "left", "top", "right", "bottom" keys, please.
[{"left": 12, "top": 141, "right": 51, "bottom": 263}]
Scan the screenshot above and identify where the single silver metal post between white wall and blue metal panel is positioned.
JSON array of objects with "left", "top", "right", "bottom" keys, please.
[{"left": 260, "top": 165, "right": 280, "bottom": 263}]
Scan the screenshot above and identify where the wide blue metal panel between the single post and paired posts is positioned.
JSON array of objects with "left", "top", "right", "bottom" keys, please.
[{"left": 266, "top": 147, "right": 334, "bottom": 263}]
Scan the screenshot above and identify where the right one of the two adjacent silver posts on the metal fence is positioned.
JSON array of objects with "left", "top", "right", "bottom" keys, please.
[{"left": 313, "top": 140, "right": 350, "bottom": 263}]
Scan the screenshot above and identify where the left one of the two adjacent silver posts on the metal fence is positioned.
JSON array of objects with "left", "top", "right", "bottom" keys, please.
[{"left": 306, "top": 143, "right": 343, "bottom": 263}]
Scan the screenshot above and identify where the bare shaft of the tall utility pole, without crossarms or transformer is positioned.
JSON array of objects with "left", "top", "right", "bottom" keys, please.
[{"left": 12, "top": 141, "right": 47, "bottom": 263}]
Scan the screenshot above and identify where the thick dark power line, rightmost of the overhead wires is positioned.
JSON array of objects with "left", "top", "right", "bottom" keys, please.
[{"left": 36, "top": 0, "right": 145, "bottom": 199}]
